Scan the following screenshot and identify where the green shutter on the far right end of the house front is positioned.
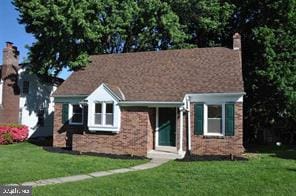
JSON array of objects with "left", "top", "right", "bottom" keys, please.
[{"left": 225, "top": 103, "right": 235, "bottom": 136}]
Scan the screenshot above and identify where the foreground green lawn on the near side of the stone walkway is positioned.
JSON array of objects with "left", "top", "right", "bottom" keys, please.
[{"left": 33, "top": 146, "right": 296, "bottom": 196}]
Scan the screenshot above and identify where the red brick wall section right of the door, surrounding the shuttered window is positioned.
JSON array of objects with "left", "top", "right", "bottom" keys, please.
[{"left": 191, "top": 103, "right": 244, "bottom": 155}]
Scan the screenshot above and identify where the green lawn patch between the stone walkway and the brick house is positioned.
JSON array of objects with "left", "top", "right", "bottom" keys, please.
[{"left": 0, "top": 142, "right": 147, "bottom": 184}]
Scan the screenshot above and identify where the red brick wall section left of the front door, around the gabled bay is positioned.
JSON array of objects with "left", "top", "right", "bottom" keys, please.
[{"left": 53, "top": 104, "right": 155, "bottom": 156}]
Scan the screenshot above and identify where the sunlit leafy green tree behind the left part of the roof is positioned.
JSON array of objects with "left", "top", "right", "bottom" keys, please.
[{"left": 13, "top": 0, "right": 186, "bottom": 77}]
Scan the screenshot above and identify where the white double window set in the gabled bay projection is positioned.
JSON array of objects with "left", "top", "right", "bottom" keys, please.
[{"left": 94, "top": 102, "right": 114, "bottom": 126}]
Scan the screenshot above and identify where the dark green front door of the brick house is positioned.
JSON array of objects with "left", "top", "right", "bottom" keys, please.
[{"left": 158, "top": 108, "right": 176, "bottom": 146}]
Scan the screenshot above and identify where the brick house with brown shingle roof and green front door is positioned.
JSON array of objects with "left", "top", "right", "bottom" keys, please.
[{"left": 53, "top": 34, "right": 244, "bottom": 157}]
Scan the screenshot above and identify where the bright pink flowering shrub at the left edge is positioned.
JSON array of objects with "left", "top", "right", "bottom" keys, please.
[{"left": 0, "top": 124, "right": 29, "bottom": 144}]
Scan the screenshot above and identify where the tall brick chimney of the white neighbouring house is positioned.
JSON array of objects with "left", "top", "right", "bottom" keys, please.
[{"left": 0, "top": 42, "right": 20, "bottom": 123}]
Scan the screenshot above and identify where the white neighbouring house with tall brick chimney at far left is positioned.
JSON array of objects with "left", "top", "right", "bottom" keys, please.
[{"left": 0, "top": 42, "right": 63, "bottom": 138}]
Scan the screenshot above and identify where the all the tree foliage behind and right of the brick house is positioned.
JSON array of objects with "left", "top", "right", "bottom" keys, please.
[{"left": 13, "top": 0, "right": 296, "bottom": 143}]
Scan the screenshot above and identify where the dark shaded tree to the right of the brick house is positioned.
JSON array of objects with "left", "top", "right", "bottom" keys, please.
[{"left": 231, "top": 0, "right": 296, "bottom": 142}]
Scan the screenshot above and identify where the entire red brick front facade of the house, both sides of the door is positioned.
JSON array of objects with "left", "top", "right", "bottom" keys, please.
[{"left": 53, "top": 103, "right": 244, "bottom": 156}]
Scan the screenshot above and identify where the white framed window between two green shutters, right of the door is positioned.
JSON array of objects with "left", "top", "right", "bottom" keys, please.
[{"left": 204, "top": 103, "right": 225, "bottom": 136}]
